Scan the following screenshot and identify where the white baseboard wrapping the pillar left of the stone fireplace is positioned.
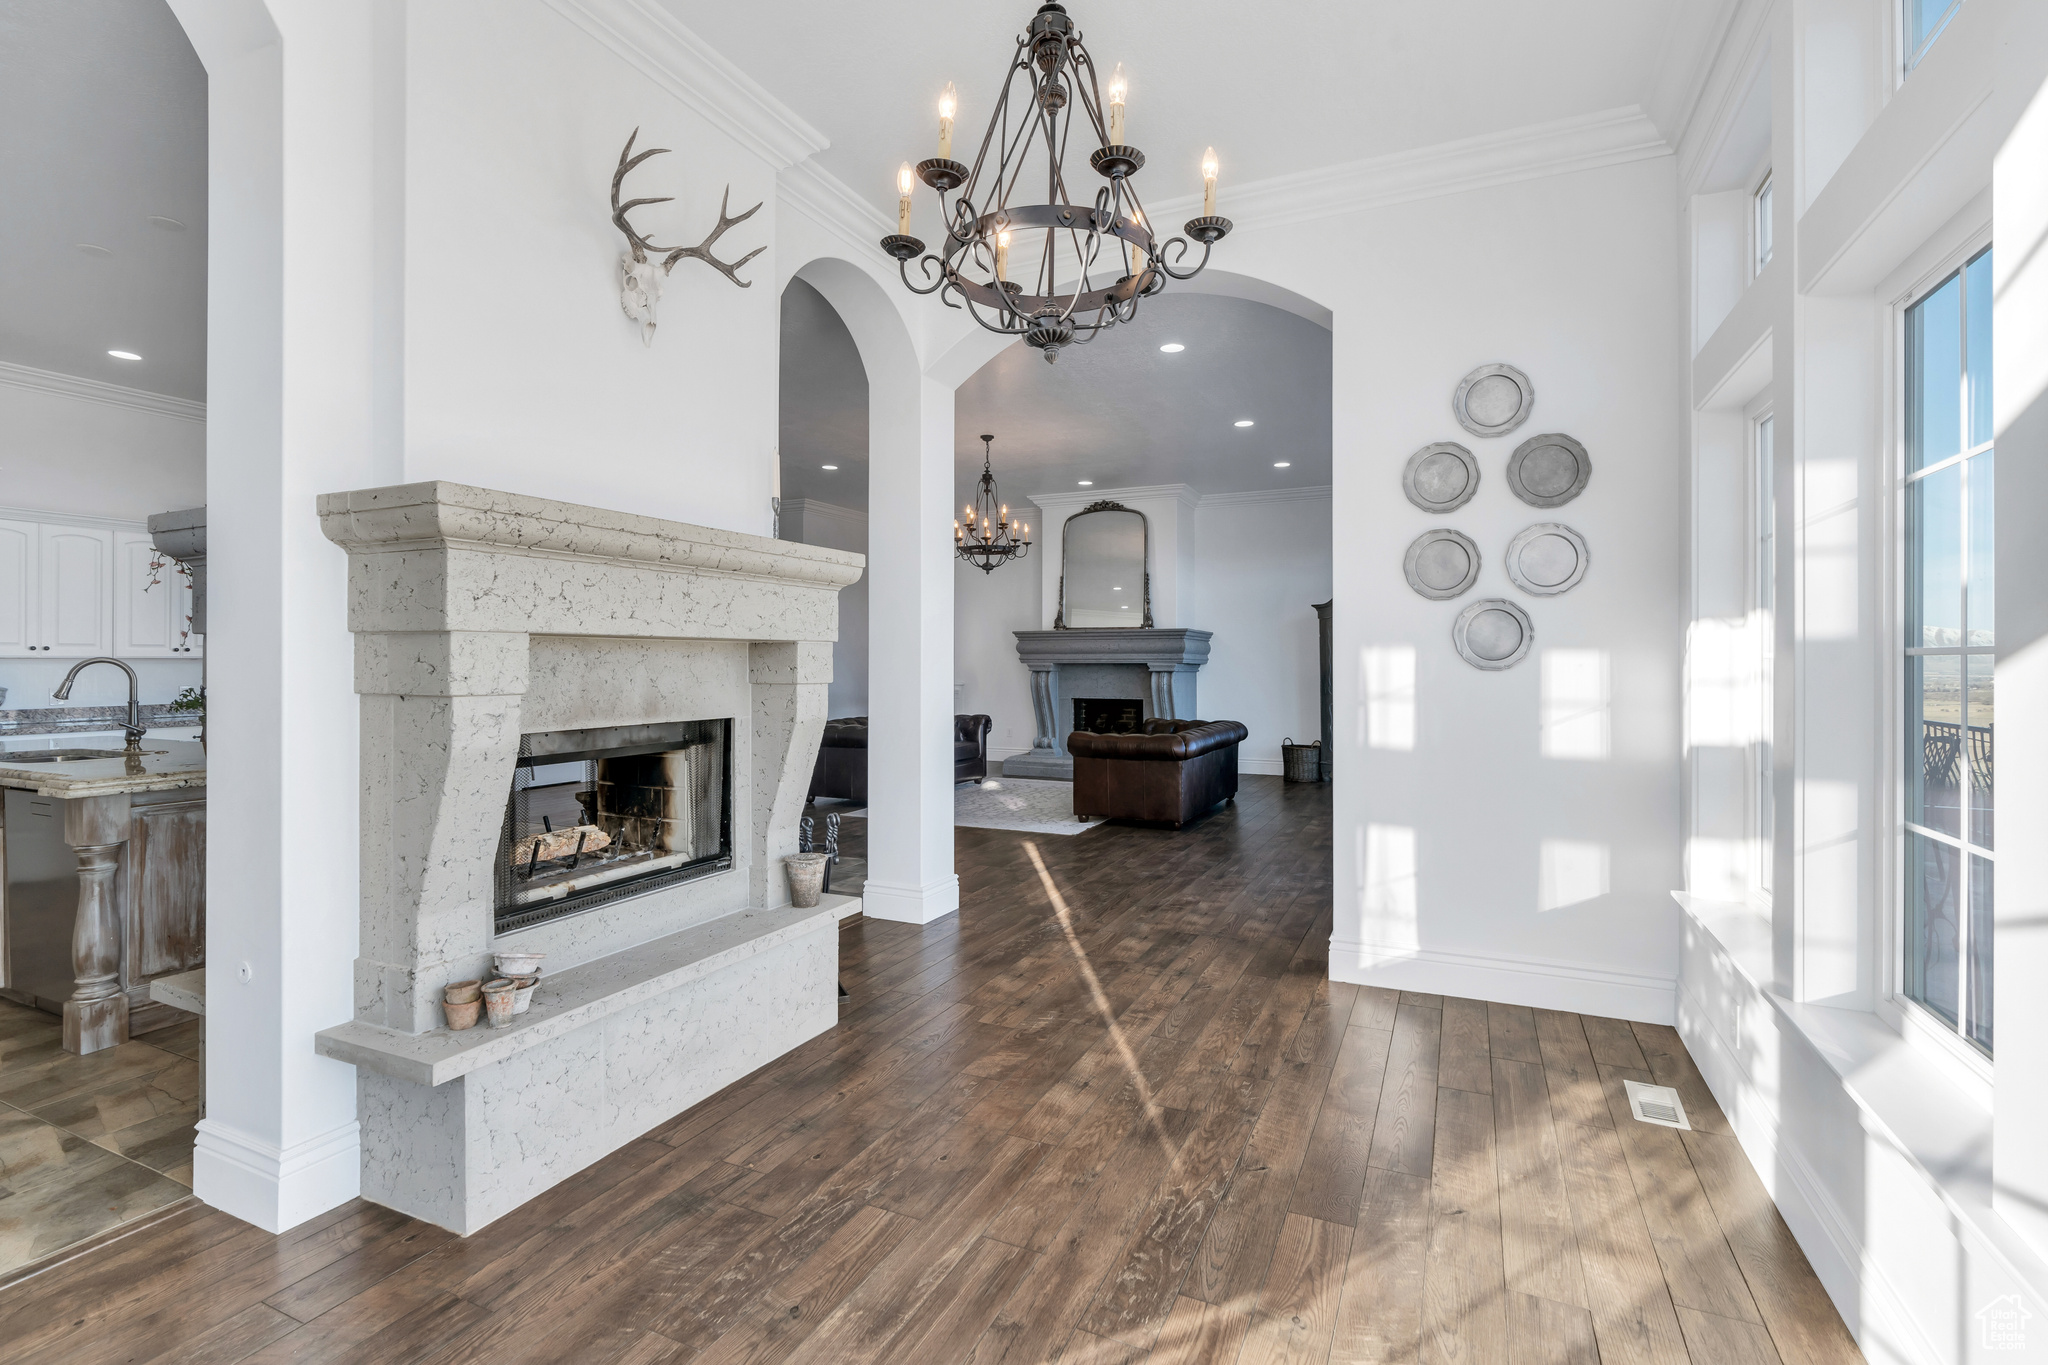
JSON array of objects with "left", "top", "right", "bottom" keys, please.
[{"left": 193, "top": 1119, "right": 362, "bottom": 1232}]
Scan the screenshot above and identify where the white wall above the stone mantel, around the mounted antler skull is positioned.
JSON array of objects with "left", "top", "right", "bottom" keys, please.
[{"left": 403, "top": 0, "right": 780, "bottom": 534}]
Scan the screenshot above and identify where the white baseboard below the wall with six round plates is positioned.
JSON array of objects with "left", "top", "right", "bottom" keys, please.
[{"left": 1329, "top": 939, "right": 1677, "bottom": 1023}]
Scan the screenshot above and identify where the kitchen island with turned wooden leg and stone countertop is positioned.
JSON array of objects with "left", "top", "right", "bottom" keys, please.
[{"left": 0, "top": 737, "right": 207, "bottom": 1054}]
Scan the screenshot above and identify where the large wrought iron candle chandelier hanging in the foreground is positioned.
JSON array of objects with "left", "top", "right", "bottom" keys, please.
[{"left": 883, "top": 0, "right": 1231, "bottom": 362}]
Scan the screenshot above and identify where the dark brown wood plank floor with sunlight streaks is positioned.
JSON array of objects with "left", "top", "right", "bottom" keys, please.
[{"left": 0, "top": 778, "right": 1860, "bottom": 1365}]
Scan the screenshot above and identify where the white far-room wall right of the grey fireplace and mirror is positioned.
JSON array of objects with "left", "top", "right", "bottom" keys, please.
[{"left": 1182, "top": 489, "right": 1331, "bottom": 776}]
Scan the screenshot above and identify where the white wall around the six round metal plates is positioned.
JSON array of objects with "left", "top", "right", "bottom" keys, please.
[{"left": 1302, "top": 158, "right": 1683, "bottom": 1021}]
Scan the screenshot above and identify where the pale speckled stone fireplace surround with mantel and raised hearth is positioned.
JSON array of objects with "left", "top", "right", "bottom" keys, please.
[{"left": 315, "top": 483, "right": 862, "bottom": 1236}]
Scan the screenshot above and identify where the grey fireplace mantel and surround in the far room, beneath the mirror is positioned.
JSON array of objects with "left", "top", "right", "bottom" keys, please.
[{"left": 1004, "top": 628, "right": 1210, "bottom": 782}]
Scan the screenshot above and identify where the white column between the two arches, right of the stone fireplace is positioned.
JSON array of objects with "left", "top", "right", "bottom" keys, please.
[{"left": 856, "top": 374, "right": 961, "bottom": 925}]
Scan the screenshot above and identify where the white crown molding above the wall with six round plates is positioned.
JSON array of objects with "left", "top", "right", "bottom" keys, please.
[{"left": 1151, "top": 104, "right": 1671, "bottom": 227}]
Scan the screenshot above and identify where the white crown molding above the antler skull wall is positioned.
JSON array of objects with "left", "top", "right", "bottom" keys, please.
[{"left": 547, "top": 0, "right": 831, "bottom": 170}]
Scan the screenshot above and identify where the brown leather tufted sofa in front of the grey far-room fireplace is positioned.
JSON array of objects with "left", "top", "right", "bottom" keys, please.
[{"left": 1067, "top": 720, "right": 1251, "bottom": 829}]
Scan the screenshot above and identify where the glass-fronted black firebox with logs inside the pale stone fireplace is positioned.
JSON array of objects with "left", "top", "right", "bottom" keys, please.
[{"left": 496, "top": 720, "right": 733, "bottom": 933}]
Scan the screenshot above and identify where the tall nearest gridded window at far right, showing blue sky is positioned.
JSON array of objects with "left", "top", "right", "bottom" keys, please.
[{"left": 1901, "top": 248, "right": 1995, "bottom": 1054}]
